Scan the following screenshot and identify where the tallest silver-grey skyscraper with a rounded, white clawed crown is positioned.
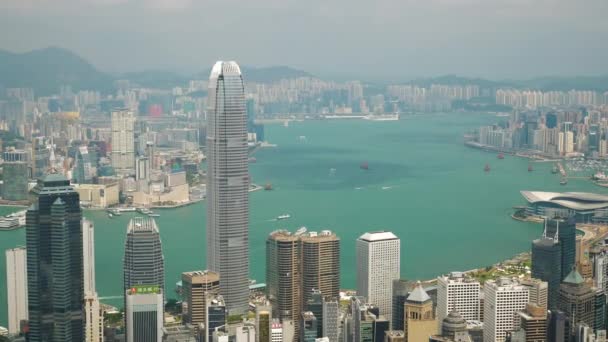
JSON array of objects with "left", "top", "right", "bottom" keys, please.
[{"left": 206, "top": 61, "right": 250, "bottom": 315}]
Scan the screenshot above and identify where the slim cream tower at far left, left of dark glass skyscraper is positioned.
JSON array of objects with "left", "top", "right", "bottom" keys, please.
[{"left": 6, "top": 247, "right": 28, "bottom": 334}]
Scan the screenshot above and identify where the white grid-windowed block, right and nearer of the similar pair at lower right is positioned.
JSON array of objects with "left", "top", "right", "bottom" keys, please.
[{"left": 483, "top": 278, "right": 530, "bottom": 342}]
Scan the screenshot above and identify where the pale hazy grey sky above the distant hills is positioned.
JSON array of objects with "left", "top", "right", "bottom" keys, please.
[{"left": 0, "top": 0, "right": 608, "bottom": 78}]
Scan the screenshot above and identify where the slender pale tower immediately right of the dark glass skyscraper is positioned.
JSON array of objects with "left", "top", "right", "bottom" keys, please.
[{"left": 82, "top": 219, "right": 103, "bottom": 342}]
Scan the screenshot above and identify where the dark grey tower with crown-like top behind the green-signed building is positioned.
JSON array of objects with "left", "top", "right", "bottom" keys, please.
[{"left": 123, "top": 217, "right": 165, "bottom": 291}]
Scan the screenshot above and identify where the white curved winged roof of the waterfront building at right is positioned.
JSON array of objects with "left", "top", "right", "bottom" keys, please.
[{"left": 521, "top": 191, "right": 608, "bottom": 210}]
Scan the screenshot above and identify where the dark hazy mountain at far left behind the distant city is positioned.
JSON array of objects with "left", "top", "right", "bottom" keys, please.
[{"left": 0, "top": 47, "right": 112, "bottom": 96}]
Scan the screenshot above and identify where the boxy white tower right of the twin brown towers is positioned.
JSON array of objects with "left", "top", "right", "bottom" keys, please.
[{"left": 357, "top": 231, "right": 401, "bottom": 321}]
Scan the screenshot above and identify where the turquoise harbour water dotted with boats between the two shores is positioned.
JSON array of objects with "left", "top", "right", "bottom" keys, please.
[{"left": 0, "top": 114, "right": 607, "bottom": 325}]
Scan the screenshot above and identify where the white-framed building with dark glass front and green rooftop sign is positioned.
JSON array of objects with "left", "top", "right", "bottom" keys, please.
[{"left": 125, "top": 285, "right": 164, "bottom": 342}]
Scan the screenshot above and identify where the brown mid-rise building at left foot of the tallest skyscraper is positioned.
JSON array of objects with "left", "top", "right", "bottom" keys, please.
[{"left": 182, "top": 271, "right": 220, "bottom": 327}]
